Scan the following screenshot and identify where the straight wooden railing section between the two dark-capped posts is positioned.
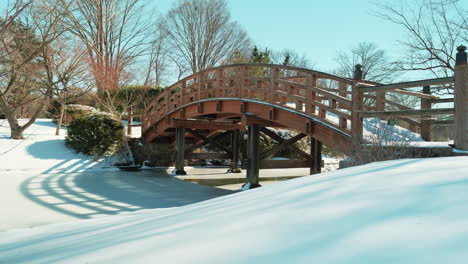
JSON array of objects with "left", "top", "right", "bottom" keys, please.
[{"left": 354, "top": 73, "right": 455, "bottom": 144}]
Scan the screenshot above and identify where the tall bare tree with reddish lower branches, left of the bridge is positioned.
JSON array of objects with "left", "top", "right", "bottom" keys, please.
[{"left": 59, "top": 0, "right": 149, "bottom": 114}]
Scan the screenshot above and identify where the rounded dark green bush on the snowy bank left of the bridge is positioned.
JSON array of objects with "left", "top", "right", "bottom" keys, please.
[{"left": 65, "top": 113, "right": 125, "bottom": 157}]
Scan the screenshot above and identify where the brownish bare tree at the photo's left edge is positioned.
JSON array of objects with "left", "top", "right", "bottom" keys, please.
[{"left": 0, "top": 0, "right": 62, "bottom": 139}]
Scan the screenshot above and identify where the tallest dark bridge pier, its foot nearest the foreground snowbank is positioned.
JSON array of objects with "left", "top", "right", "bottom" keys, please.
[{"left": 243, "top": 124, "right": 261, "bottom": 189}]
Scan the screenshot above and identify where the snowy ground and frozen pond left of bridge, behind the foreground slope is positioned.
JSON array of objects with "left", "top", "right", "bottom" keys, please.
[{"left": 0, "top": 119, "right": 232, "bottom": 231}]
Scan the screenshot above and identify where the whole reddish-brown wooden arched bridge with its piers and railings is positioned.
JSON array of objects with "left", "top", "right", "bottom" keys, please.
[{"left": 142, "top": 47, "right": 468, "bottom": 186}]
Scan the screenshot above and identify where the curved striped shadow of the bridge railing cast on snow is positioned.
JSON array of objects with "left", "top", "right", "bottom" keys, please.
[{"left": 21, "top": 170, "right": 233, "bottom": 219}]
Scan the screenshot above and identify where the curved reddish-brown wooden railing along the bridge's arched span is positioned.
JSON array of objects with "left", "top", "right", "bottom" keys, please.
[{"left": 143, "top": 64, "right": 354, "bottom": 136}]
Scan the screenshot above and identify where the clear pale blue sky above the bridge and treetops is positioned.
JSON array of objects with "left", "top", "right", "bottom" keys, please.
[{"left": 152, "top": 0, "right": 410, "bottom": 74}]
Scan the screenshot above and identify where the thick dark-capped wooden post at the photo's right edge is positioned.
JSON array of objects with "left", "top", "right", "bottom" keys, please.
[{"left": 455, "top": 45, "right": 468, "bottom": 150}]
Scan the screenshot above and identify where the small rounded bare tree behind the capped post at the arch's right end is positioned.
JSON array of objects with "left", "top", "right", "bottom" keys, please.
[{"left": 335, "top": 42, "right": 397, "bottom": 82}]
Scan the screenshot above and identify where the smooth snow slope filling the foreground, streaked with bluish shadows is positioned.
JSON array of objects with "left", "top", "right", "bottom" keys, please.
[{"left": 0, "top": 157, "right": 468, "bottom": 264}]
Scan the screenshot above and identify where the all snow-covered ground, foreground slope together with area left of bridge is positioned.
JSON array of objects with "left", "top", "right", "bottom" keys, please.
[{"left": 0, "top": 120, "right": 468, "bottom": 264}]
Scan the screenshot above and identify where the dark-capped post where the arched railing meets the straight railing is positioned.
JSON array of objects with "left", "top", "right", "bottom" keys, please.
[{"left": 351, "top": 64, "right": 363, "bottom": 152}]
